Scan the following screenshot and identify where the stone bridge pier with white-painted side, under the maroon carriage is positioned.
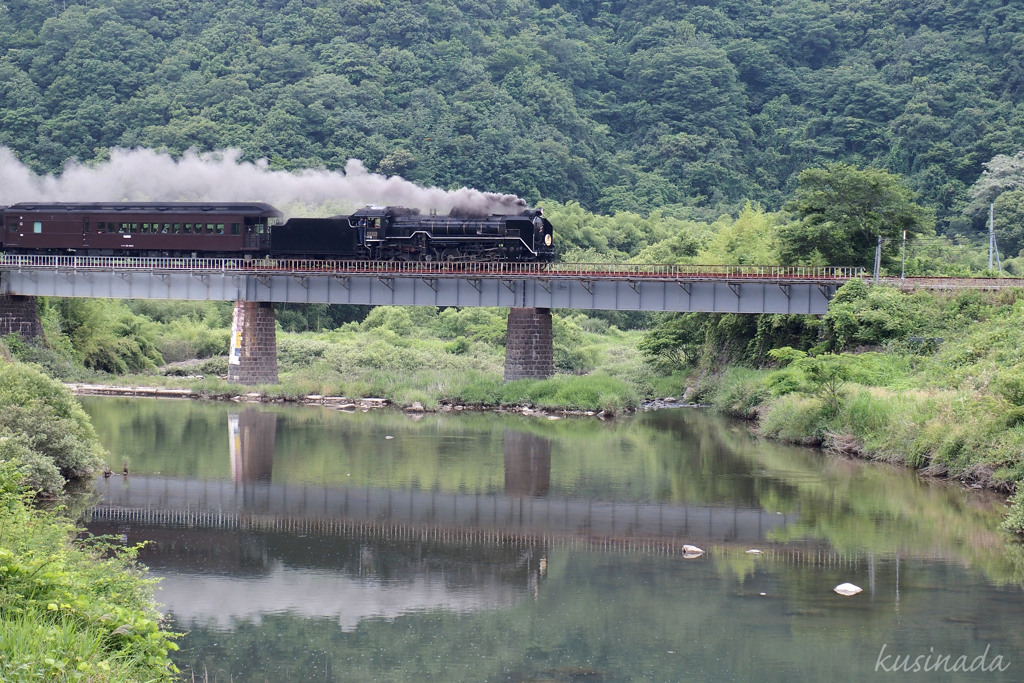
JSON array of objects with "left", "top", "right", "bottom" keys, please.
[{"left": 227, "top": 301, "right": 278, "bottom": 384}]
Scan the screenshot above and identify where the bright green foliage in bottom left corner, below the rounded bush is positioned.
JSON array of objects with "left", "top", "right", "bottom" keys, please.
[{"left": 0, "top": 460, "right": 177, "bottom": 681}]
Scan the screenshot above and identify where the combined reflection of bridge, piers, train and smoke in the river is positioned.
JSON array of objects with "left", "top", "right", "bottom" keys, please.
[{"left": 89, "top": 409, "right": 802, "bottom": 630}]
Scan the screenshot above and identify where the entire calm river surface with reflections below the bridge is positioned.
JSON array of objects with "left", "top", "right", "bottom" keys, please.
[{"left": 83, "top": 398, "right": 1024, "bottom": 683}]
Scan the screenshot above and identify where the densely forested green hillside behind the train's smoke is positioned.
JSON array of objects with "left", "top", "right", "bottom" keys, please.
[{"left": 0, "top": 0, "right": 1024, "bottom": 231}]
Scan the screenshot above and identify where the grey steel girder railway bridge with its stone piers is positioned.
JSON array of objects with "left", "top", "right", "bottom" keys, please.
[{"left": 0, "top": 255, "right": 864, "bottom": 384}]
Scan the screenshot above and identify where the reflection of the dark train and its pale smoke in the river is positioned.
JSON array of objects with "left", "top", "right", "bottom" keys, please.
[{"left": 90, "top": 521, "right": 546, "bottom": 631}]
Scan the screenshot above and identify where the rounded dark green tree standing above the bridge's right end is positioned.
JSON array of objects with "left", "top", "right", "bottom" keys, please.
[{"left": 778, "top": 163, "right": 934, "bottom": 267}]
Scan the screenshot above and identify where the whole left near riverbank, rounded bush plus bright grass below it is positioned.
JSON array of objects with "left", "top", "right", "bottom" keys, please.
[{"left": 0, "top": 359, "right": 176, "bottom": 682}]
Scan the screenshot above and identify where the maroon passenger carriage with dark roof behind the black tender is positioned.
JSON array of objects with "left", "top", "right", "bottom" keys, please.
[{"left": 0, "top": 202, "right": 282, "bottom": 257}]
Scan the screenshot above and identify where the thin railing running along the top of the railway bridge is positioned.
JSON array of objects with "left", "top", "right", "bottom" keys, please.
[{"left": 0, "top": 254, "right": 865, "bottom": 281}]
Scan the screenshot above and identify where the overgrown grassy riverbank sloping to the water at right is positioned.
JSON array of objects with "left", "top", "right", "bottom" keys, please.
[{"left": 697, "top": 283, "right": 1024, "bottom": 533}]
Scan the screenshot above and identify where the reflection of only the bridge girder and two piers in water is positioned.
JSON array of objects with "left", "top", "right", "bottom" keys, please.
[{"left": 92, "top": 410, "right": 788, "bottom": 549}]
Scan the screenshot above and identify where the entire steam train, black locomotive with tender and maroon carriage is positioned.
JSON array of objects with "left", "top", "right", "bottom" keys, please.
[{"left": 0, "top": 202, "right": 554, "bottom": 261}]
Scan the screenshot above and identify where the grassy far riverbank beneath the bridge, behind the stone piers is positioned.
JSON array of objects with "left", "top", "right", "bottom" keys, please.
[{"left": 7, "top": 302, "right": 684, "bottom": 414}]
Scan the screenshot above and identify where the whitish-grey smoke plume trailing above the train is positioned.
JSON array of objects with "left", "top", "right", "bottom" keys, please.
[{"left": 0, "top": 147, "right": 526, "bottom": 215}]
